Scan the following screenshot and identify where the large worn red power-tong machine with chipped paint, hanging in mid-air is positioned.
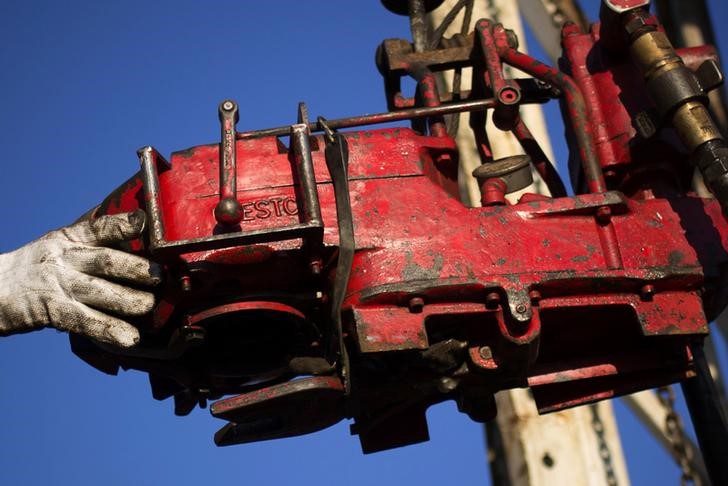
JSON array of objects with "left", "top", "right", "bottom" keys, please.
[{"left": 71, "top": 1, "right": 728, "bottom": 452}]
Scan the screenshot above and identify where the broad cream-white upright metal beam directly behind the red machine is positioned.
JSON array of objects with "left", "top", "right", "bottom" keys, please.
[{"left": 430, "top": 0, "right": 629, "bottom": 486}]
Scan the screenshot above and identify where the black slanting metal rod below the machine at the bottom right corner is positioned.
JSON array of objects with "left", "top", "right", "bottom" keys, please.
[{"left": 680, "top": 345, "right": 728, "bottom": 485}]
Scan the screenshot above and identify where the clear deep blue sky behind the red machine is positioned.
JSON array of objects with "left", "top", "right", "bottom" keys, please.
[{"left": 0, "top": 0, "right": 728, "bottom": 485}]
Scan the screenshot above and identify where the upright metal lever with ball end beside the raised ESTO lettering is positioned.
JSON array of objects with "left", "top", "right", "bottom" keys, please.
[{"left": 215, "top": 100, "right": 243, "bottom": 226}]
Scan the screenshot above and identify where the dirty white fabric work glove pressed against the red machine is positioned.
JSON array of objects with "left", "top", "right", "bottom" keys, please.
[{"left": 0, "top": 210, "right": 161, "bottom": 347}]
